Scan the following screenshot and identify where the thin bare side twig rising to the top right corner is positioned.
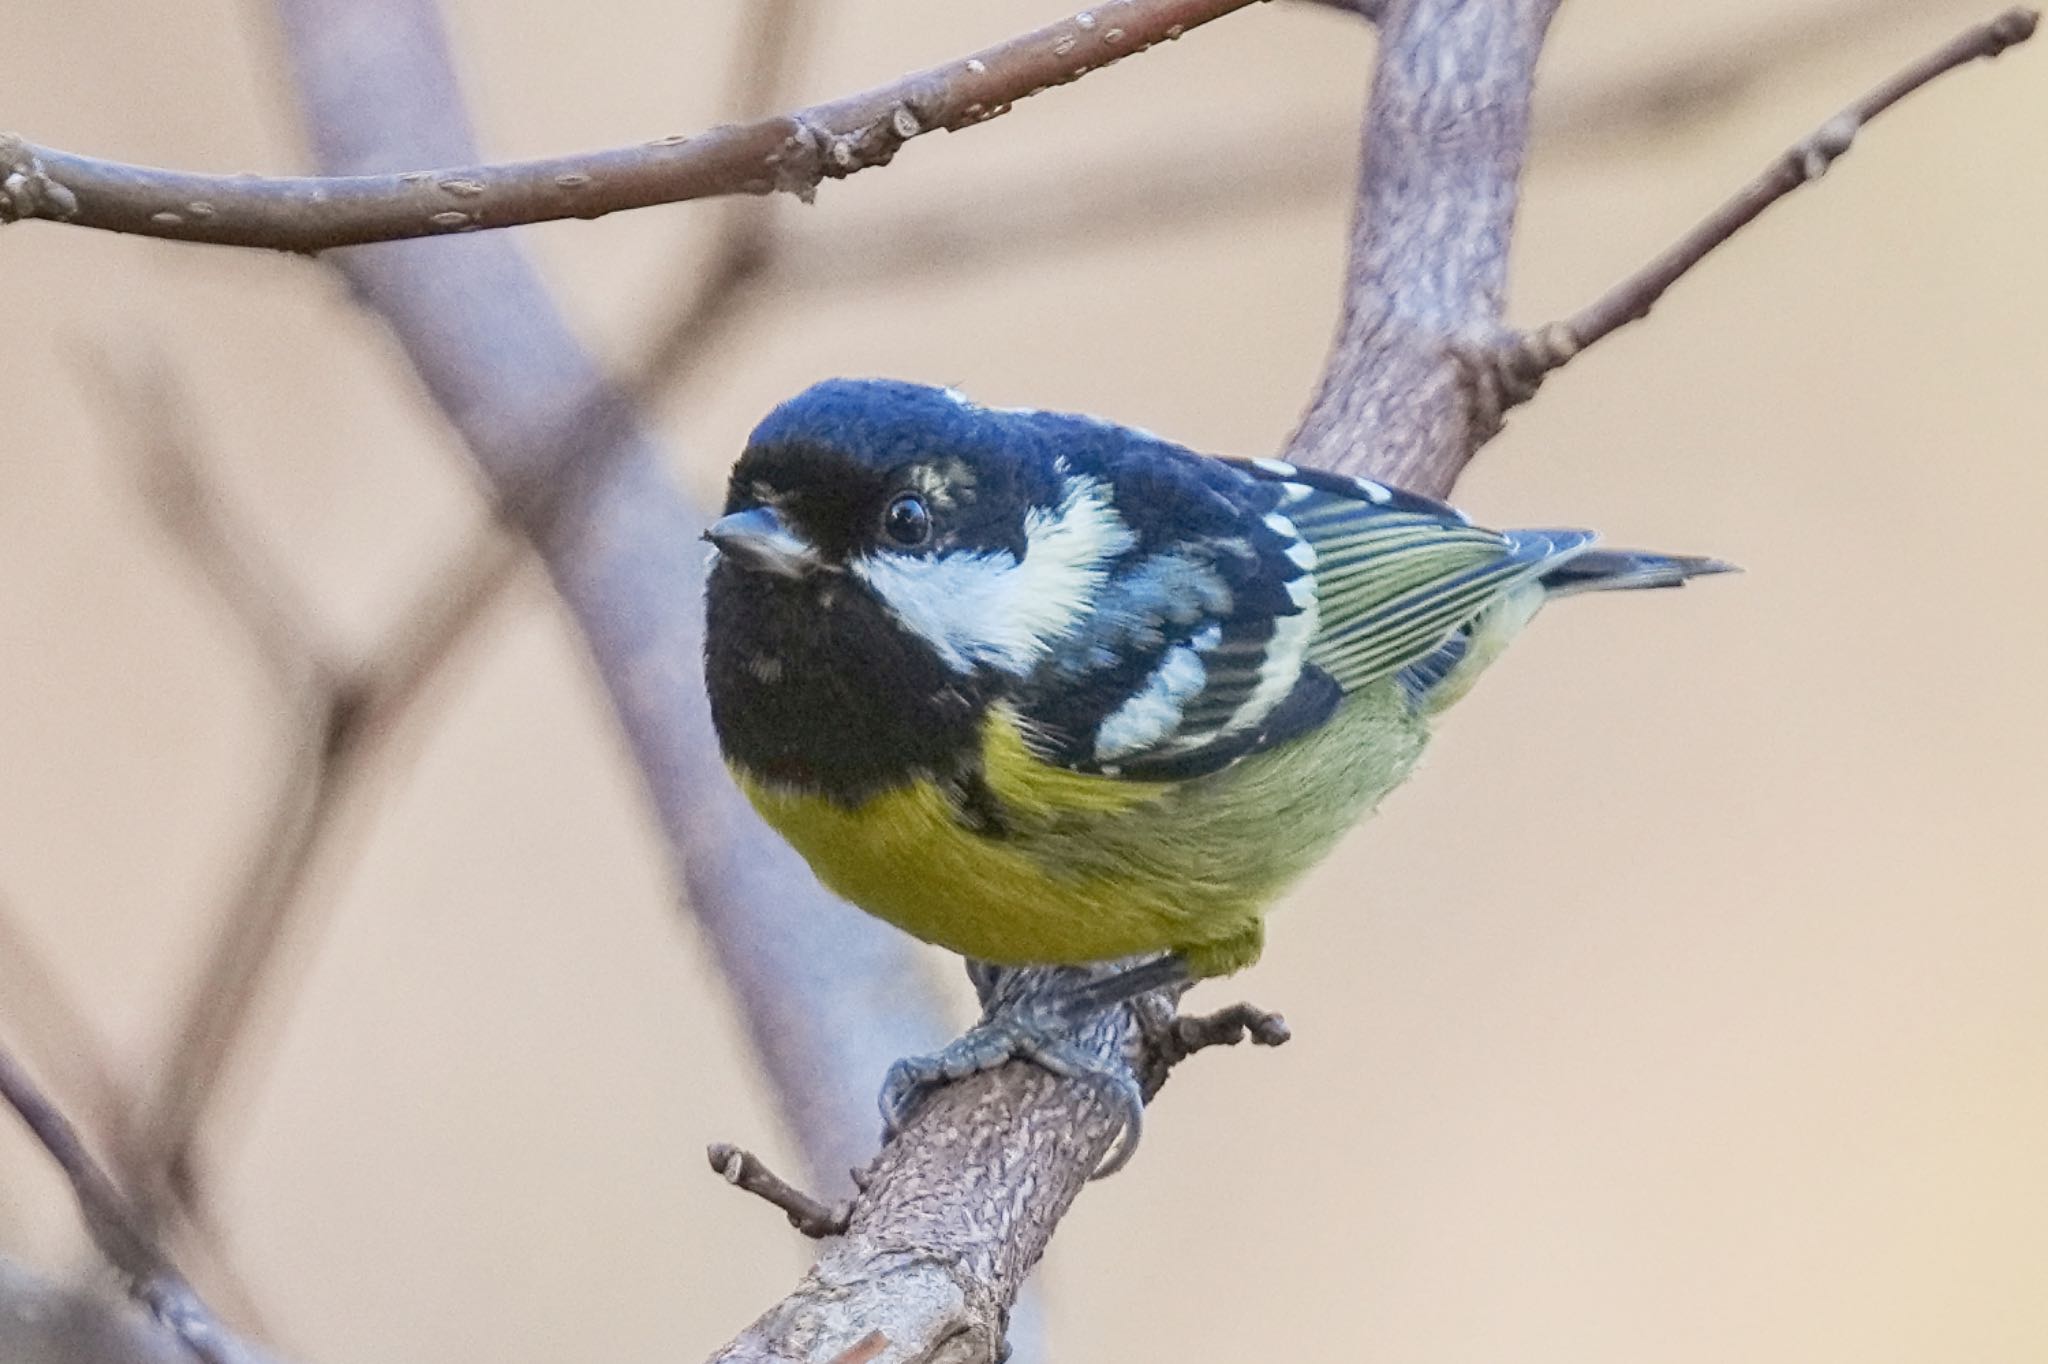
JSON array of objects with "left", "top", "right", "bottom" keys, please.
[{"left": 1473, "top": 8, "right": 2040, "bottom": 414}]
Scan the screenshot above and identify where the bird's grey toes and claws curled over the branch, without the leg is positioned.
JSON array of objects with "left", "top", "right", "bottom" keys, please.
[{"left": 881, "top": 1010, "right": 1145, "bottom": 1180}]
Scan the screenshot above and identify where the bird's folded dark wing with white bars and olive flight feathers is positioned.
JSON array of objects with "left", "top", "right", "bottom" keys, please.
[{"left": 1016, "top": 461, "right": 1591, "bottom": 780}]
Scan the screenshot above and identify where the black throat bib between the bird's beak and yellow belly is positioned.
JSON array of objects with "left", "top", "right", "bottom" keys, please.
[{"left": 705, "top": 561, "right": 991, "bottom": 807}]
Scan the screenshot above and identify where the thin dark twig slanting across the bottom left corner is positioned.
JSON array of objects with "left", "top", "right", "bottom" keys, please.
[{"left": 0, "top": 1047, "right": 288, "bottom": 1364}]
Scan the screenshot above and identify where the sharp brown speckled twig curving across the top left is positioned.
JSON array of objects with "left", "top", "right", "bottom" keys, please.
[{"left": 0, "top": 0, "right": 1251, "bottom": 252}]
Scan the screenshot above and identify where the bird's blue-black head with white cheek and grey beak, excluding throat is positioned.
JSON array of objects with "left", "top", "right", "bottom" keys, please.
[{"left": 705, "top": 379, "right": 1135, "bottom": 676}]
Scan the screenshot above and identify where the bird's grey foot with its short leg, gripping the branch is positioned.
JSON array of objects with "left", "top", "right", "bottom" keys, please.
[{"left": 881, "top": 956, "right": 1188, "bottom": 1180}]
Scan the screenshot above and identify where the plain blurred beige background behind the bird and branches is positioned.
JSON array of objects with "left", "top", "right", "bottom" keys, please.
[{"left": 0, "top": 0, "right": 2048, "bottom": 1364}]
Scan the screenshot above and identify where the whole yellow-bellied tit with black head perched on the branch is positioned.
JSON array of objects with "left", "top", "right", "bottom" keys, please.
[{"left": 705, "top": 379, "right": 1729, "bottom": 1153}]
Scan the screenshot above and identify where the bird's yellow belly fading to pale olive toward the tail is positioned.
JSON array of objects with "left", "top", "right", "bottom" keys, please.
[{"left": 737, "top": 686, "right": 1425, "bottom": 975}]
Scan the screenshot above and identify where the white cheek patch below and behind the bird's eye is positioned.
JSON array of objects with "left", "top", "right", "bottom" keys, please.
[{"left": 848, "top": 479, "right": 1137, "bottom": 676}]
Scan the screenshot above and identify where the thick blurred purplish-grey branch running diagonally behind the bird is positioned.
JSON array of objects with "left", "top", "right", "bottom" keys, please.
[{"left": 279, "top": 0, "right": 942, "bottom": 1186}]
